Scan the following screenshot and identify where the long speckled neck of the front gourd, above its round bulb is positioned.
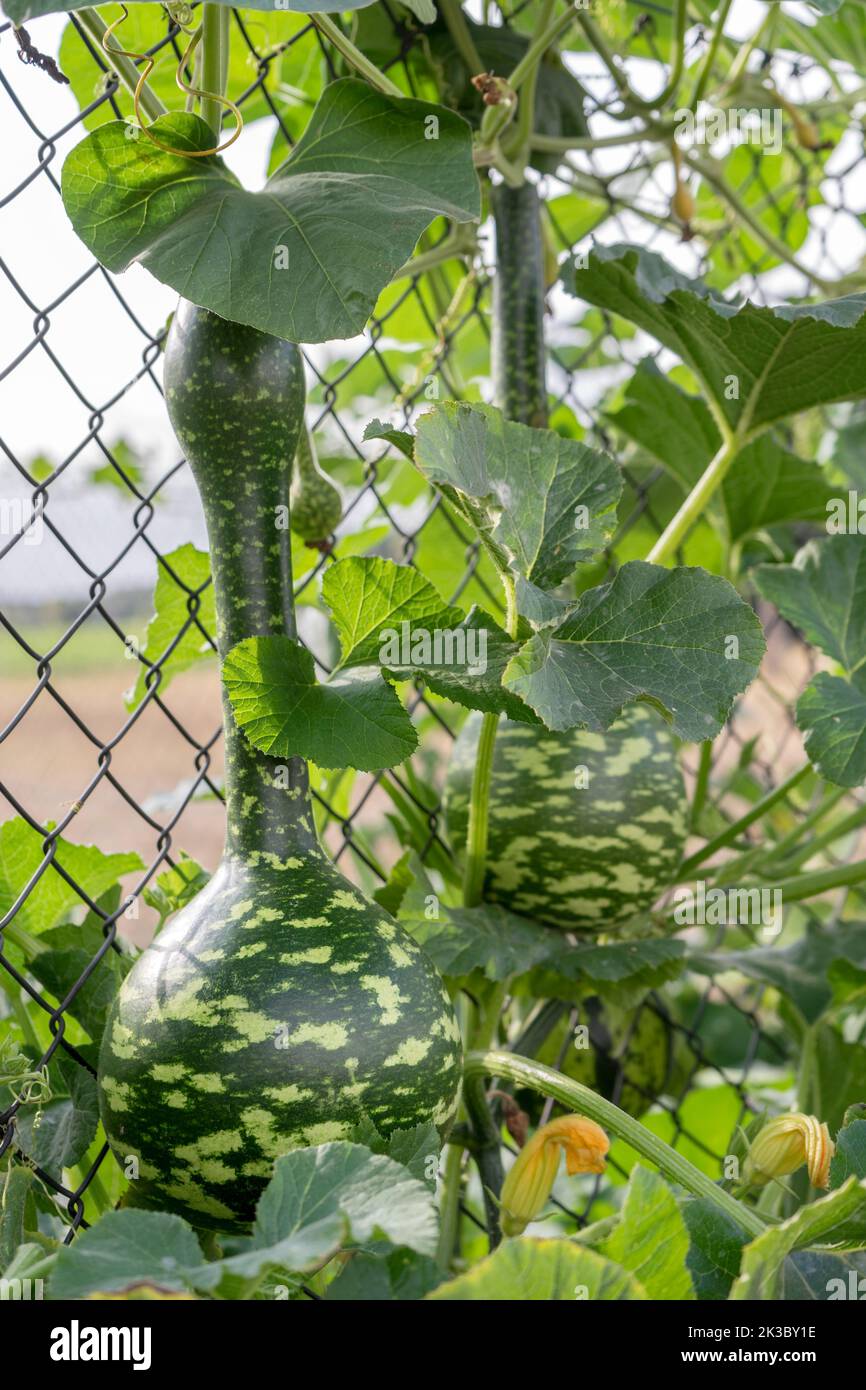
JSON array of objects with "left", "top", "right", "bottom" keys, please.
[{"left": 165, "top": 303, "right": 321, "bottom": 862}]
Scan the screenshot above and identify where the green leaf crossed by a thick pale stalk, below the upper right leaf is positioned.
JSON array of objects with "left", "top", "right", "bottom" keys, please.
[{"left": 610, "top": 357, "right": 838, "bottom": 541}]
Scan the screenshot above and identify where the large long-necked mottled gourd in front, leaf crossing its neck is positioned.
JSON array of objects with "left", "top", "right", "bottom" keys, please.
[{"left": 100, "top": 303, "right": 460, "bottom": 1230}]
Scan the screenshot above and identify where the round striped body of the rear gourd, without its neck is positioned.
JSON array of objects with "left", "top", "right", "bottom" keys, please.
[{"left": 445, "top": 705, "right": 687, "bottom": 933}]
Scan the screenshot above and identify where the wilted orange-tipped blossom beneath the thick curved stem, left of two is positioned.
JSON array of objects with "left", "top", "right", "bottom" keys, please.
[{"left": 499, "top": 1115, "right": 610, "bottom": 1236}]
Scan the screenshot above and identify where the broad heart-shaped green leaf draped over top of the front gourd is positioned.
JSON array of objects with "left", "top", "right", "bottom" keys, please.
[{"left": 63, "top": 78, "right": 480, "bottom": 342}]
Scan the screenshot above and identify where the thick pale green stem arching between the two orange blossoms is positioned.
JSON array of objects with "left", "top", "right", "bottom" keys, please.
[{"left": 463, "top": 1051, "right": 766, "bottom": 1236}]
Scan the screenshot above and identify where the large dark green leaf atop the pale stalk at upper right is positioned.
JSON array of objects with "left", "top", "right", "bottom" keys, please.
[{"left": 563, "top": 245, "right": 866, "bottom": 432}]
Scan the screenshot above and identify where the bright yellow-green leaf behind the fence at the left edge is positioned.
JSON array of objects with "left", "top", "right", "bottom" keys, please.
[{"left": 0, "top": 817, "right": 145, "bottom": 933}]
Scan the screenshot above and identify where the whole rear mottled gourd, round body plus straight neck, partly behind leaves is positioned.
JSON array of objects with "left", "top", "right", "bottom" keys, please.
[{"left": 445, "top": 182, "right": 687, "bottom": 933}]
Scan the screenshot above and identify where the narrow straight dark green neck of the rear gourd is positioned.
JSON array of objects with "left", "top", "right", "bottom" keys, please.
[{"left": 491, "top": 183, "right": 548, "bottom": 428}]
